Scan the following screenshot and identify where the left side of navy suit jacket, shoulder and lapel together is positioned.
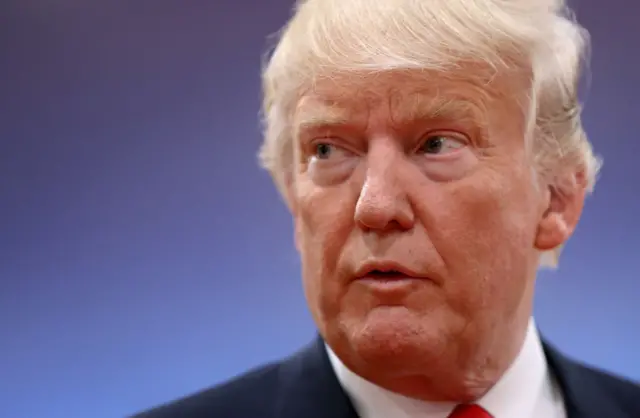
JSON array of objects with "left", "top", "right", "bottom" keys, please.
[{"left": 132, "top": 336, "right": 344, "bottom": 418}]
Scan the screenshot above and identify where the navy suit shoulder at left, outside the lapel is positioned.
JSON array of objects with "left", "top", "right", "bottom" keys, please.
[{"left": 131, "top": 363, "right": 280, "bottom": 418}]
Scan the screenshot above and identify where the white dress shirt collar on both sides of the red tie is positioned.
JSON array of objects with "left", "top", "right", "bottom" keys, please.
[{"left": 327, "top": 319, "right": 566, "bottom": 418}]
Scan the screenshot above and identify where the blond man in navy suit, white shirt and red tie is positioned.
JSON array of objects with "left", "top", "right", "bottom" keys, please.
[{"left": 132, "top": 0, "right": 640, "bottom": 418}]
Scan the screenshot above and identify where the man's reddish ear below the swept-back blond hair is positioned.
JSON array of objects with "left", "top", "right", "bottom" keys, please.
[{"left": 535, "top": 172, "right": 586, "bottom": 251}]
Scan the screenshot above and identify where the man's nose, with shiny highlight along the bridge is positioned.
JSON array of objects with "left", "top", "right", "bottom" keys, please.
[{"left": 355, "top": 144, "right": 415, "bottom": 231}]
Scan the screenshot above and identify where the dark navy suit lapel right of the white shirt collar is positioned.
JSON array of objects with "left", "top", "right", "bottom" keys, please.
[{"left": 543, "top": 341, "right": 627, "bottom": 418}]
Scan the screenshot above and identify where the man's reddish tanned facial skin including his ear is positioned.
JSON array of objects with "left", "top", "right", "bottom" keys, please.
[{"left": 289, "top": 72, "right": 584, "bottom": 401}]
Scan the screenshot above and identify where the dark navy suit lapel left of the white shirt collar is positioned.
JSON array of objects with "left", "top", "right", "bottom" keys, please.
[{"left": 276, "top": 337, "right": 358, "bottom": 418}]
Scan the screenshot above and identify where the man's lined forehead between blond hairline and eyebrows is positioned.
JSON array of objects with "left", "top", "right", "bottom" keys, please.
[{"left": 293, "top": 71, "right": 526, "bottom": 130}]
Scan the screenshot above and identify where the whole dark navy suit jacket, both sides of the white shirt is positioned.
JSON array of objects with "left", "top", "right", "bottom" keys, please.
[{"left": 133, "top": 338, "right": 640, "bottom": 418}]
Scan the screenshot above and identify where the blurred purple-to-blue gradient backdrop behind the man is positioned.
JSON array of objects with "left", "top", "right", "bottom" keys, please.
[{"left": 0, "top": 0, "right": 640, "bottom": 418}]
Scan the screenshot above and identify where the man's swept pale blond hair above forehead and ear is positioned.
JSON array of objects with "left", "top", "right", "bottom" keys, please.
[{"left": 259, "top": 0, "right": 600, "bottom": 267}]
